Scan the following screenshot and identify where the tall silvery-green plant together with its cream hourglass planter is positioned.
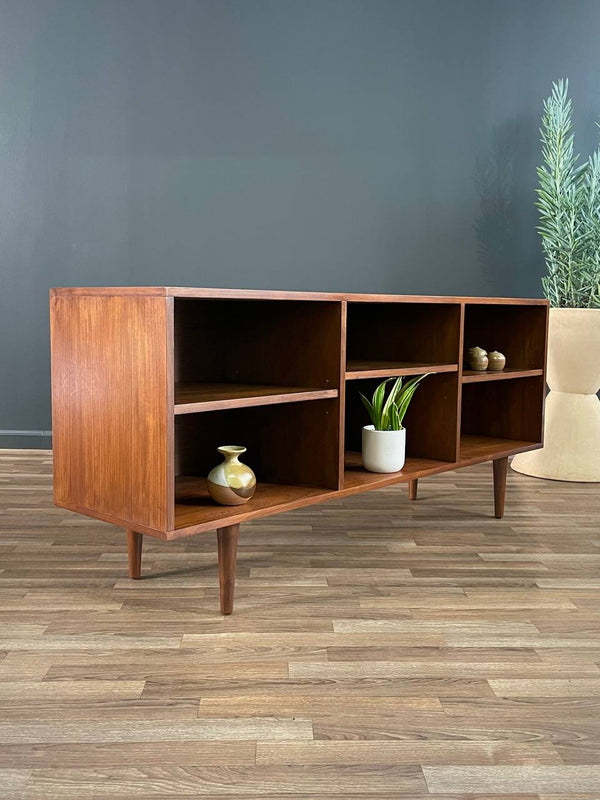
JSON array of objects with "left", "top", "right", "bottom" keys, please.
[{"left": 512, "top": 80, "right": 600, "bottom": 482}]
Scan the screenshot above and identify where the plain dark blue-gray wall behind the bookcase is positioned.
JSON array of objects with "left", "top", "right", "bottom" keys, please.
[{"left": 0, "top": 0, "right": 600, "bottom": 446}]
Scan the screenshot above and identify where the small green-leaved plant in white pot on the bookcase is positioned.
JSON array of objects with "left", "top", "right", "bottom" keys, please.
[{"left": 360, "top": 373, "right": 430, "bottom": 472}]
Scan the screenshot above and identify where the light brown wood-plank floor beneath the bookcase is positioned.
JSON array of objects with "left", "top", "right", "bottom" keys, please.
[{"left": 0, "top": 451, "right": 600, "bottom": 800}]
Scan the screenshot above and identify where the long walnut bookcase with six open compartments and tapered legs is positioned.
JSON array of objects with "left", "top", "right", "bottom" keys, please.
[{"left": 50, "top": 287, "right": 548, "bottom": 613}]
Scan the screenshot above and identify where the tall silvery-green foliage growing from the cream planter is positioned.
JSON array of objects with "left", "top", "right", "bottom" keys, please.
[{"left": 536, "top": 80, "right": 600, "bottom": 308}]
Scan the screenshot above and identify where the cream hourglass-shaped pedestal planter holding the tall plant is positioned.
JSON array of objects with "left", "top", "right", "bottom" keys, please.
[{"left": 512, "top": 308, "right": 600, "bottom": 482}]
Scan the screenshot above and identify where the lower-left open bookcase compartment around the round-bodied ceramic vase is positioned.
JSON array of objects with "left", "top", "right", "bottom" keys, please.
[{"left": 175, "top": 398, "right": 340, "bottom": 528}]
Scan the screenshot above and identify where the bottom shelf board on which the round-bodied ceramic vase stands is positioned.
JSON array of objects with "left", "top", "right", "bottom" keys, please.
[{"left": 175, "top": 475, "right": 328, "bottom": 538}]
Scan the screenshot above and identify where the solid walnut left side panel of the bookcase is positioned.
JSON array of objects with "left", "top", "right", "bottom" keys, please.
[{"left": 51, "top": 296, "right": 173, "bottom": 530}]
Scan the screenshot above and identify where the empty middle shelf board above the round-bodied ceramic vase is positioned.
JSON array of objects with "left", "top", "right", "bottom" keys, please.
[{"left": 174, "top": 383, "right": 338, "bottom": 414}]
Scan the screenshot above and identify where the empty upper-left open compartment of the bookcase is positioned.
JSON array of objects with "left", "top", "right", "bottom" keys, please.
[{"left": 174, "top": 297, "right": 341, "bottom": 414}]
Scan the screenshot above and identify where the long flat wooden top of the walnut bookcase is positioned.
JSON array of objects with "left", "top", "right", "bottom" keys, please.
[{"left": 50, "top": 286, "right": 549, "bottom": 306}]
